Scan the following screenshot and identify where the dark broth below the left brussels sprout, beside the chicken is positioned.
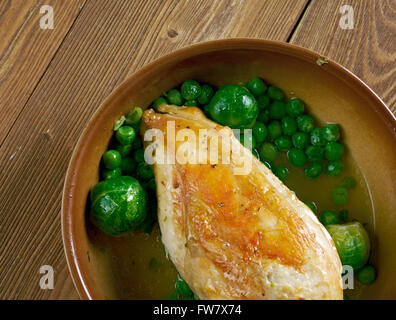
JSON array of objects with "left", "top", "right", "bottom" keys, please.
[{"left": 90, "top": 224, "right": 177, "bottom": 299}]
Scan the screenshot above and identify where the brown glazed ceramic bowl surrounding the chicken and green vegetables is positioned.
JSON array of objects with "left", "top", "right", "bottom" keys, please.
[{"left": 62, "top": 39, "right": 396, "bottom": 299}]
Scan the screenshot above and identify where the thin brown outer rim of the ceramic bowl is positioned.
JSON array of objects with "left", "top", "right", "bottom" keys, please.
[{"left": 61, "top": 38, "right": 396, "bottom": 299}]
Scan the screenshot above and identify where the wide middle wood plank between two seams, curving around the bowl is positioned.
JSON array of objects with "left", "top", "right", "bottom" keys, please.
[{"left": 0, "top": 0, "right": 306, "bottom": 299}]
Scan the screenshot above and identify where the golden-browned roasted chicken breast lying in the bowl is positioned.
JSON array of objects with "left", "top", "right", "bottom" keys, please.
[{"left": 142, "top": 105, "right": 343, "bottom": 299}]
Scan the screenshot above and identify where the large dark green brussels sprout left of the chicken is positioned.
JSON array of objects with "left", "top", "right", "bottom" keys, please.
[{"left": 90, "top": 176, "right": 147, "bottom": 235}]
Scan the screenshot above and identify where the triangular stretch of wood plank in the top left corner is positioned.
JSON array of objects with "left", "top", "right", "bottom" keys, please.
[{"left": 0, "top": 0, "right": 85, "bottom": 145}]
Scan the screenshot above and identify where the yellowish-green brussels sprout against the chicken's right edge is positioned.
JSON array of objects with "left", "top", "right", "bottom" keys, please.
[{"left": 326, "top": 222, "right": 370, "bottom": 270}]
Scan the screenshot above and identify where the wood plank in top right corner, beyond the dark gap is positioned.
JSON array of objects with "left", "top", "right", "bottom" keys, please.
[{"left": 290, "top": 0, "right": 396, "bottom": 114}]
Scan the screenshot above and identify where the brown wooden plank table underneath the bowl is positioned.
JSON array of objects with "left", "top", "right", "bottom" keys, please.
[{"left": 0, "top": 0, "right": 396, "bottom": 299}]
